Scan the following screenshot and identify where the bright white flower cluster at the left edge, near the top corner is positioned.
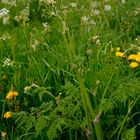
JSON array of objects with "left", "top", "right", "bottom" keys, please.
[{"left": 0, "top": 8, "right": 9, "bottom": 25}]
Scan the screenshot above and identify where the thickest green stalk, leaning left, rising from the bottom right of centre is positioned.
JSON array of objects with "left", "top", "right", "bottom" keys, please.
[{"left": 63, "top": 28, "right": 103, "bottom": 140}]
